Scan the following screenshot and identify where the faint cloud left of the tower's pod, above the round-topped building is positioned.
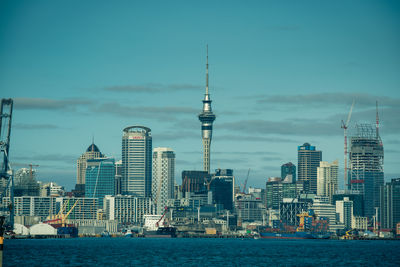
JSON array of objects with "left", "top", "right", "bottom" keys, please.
[{"left": 92, "top": 102, "right": 198, "bottom": 120}]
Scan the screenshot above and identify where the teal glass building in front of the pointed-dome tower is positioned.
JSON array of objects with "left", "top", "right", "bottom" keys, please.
[{"left": 85, "top": 159, "right": 115, "bottom": 207}]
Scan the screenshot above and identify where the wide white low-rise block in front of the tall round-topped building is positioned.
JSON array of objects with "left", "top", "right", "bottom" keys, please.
[{"left": 104, "top": 195, "right": 153, "bottom": 225}]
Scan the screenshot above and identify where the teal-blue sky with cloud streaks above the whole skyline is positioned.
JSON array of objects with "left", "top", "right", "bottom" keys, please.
[{"left": 0, "top": 0, "right": 400, "bottom": 192}]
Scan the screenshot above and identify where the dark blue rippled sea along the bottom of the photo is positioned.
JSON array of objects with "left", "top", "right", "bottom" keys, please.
[{"left": 3, "top": 238, "right": 400, "bottom": 267}]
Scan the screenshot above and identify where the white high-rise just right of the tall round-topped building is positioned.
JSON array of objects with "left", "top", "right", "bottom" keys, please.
[{"left": 151, "top": 147, "right": 175, "bottom": 214}]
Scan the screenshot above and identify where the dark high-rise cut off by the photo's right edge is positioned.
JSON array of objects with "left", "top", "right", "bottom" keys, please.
[{"left": 379, "top": 178, "right": 400, "bottom": 229}]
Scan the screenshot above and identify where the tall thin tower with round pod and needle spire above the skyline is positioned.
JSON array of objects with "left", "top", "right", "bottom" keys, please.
[{"left": 199, "top": 45, "right": 215, "bottom": 173}]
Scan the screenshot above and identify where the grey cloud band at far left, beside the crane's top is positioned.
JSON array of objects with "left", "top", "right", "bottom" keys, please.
[{"left": 14, "top": 98, "right": 92, "bottom": 110}]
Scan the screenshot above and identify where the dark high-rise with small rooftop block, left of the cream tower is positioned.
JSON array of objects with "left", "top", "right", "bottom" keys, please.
[{"left": 297, "top": 143, "right": 322, "bottom": 193}]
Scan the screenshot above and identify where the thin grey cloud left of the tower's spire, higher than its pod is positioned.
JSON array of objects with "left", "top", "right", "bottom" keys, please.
[{"left": 104, "top": 83, "right": 202, "bottom": 93}]
